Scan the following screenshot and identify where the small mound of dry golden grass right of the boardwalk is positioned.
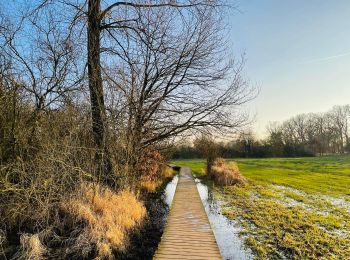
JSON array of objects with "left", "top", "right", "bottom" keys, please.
[{"left": 211, "top": 158, "right": 246, "bottom": 185}]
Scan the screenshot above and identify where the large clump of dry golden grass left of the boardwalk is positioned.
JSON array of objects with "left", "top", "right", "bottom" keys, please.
[{"left": 63, "top": 184, "right": 146, "bottom": 258}]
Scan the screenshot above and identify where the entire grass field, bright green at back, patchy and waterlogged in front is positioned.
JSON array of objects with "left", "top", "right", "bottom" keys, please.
[{"left": 174, "top": 155, "right": 350, "bottom": 259}]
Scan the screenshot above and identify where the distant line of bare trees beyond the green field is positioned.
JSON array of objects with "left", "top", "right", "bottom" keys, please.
[{"left": 173, "top": 105, "right": 350, "bottom": 159}]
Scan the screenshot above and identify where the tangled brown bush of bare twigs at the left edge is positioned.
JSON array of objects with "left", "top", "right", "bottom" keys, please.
[{"left": 0, "top": 104, "right": 94, "bottom": 229}]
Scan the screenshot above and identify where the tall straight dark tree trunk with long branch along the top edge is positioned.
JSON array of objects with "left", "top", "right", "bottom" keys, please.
[{"left": 86, "top": 0, "right": 213, "bottom": 150}]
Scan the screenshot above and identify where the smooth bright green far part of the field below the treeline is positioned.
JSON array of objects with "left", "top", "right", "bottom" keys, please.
[{"left": 174, "top": 156, "right": 350, "bottom": 196}]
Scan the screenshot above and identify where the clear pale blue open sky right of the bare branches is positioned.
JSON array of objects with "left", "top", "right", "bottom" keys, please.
[{"left": 229, "top": 0, "right": 350, "bottom": 135}]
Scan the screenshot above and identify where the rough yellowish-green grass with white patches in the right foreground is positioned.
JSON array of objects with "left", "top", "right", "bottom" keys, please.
[{"left": 217, "top": 183, "right": 350, "bottom": 259}]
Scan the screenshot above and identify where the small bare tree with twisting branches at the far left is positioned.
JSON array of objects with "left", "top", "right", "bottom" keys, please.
[{"left": 0, "top": 6, "right": 81, "bottom": 150}]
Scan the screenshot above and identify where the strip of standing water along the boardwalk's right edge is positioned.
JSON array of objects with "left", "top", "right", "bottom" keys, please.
[{"left": 196, "top": 179, "right": 254, "bottom": 260}]
